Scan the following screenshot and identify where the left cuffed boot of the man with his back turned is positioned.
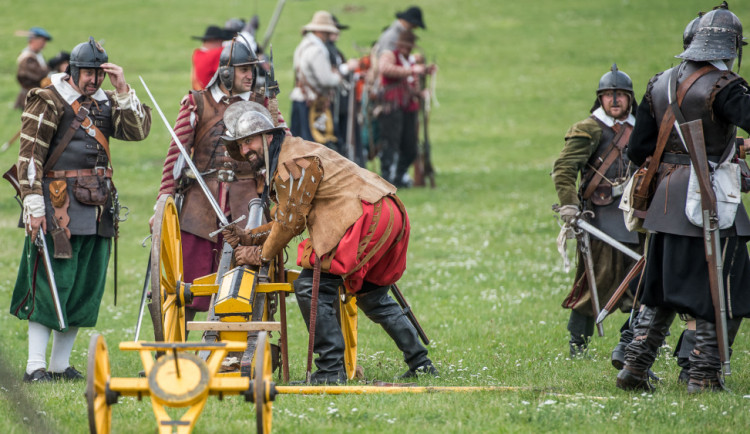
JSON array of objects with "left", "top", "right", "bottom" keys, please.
[{"left": 616, "top": 307, "right": 675, "bottom": 392}]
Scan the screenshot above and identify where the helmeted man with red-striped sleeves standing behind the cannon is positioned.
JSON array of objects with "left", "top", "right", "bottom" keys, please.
[{"left": 150, "top": 36, "right": 286, "bottom": 321}]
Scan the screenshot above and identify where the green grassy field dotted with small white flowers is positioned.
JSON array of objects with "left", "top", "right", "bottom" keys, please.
[{"left": 0, "top": 0, "right": 750, "bottom": 433}]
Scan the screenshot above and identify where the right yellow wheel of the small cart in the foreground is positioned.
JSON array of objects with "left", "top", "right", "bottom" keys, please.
[{"left": 253, "top": 332, "right": 276, "bottom": 434}]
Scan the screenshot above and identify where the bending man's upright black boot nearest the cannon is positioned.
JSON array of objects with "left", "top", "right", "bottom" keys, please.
[{"left": 294, "top": 270, "right": 346, "bottom": 384}]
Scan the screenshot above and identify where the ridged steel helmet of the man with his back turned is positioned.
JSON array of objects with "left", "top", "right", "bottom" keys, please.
[{"left": 676, "top": 5, "right": 746, "bottom": 62}]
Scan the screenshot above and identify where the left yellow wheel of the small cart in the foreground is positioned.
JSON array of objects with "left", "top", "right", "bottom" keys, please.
[{"left": 86, "top": 334, "right": 112, "bottom": 433}]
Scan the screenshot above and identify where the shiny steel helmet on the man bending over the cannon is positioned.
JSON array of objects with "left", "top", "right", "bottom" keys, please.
[{"left": 221, "top": 101, "right": 284, "bottom": 161}]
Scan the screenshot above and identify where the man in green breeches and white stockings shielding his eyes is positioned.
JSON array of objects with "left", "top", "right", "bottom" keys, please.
[{"left": 10, "top": 38, "right": 151, "bottom": 382}]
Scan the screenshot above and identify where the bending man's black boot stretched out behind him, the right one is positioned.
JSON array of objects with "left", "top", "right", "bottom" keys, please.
[{"left": 357, "top": 282, "right": 438, "bottom": 378}]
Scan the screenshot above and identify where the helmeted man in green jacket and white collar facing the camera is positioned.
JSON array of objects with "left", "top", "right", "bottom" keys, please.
[{"left": 552, "top": 65, "right": 643, "bottom": 362}]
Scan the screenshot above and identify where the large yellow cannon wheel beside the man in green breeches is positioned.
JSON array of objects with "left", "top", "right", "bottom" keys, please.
[{"left": 150, "top": 195, "right": 185, "bottom": 342}]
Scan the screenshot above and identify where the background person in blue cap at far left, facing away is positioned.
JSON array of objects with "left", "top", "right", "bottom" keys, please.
[{"left": 13, "top": 27, "right": 52, "bottom": 109}]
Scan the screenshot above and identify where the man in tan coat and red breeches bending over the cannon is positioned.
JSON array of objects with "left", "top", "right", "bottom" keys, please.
[{"left": 219, "top": 101, "right": 437, "bottom": 384}]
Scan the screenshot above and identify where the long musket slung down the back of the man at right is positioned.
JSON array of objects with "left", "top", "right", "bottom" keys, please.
[{"left": 675, "top": 119, "right": 732, "bottom": 375}]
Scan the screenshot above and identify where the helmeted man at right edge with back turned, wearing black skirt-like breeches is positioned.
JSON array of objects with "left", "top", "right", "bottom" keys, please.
[{"left": 617, "top": 2, "right": 750, "bottom": 393}]
